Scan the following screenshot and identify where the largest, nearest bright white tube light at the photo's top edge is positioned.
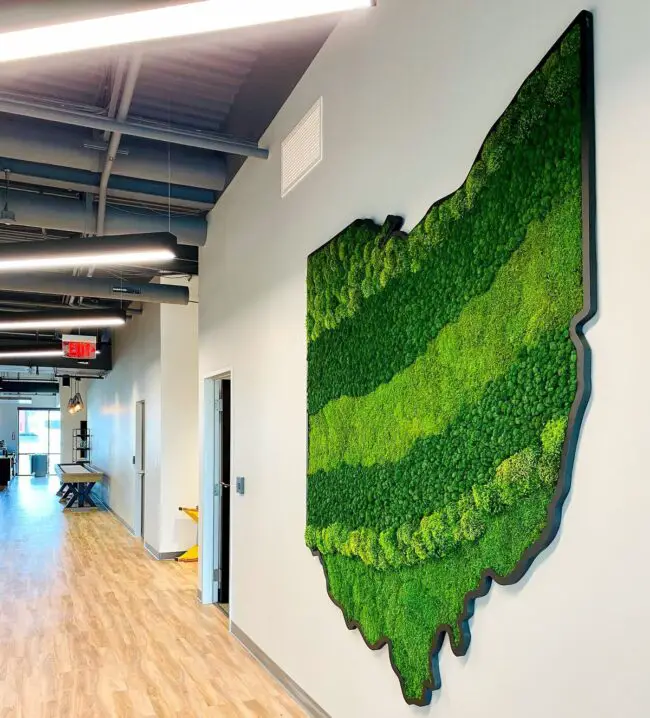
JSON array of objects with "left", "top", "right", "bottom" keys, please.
[{"left": 0, "top": 0, "right": 374, "bottom": 62}]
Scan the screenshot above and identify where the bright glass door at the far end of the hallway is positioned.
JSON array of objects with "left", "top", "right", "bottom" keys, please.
[{"left": 18, "top": 409, "right": 61, "bottom": 476}]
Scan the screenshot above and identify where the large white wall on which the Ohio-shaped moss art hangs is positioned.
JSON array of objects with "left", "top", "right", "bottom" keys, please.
[{"left": 200, "top": 0, "right": 650, "bottom": 718}]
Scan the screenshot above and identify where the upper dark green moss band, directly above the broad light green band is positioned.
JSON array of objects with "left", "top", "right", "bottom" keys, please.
[{"left": 308, "top": 39, "right": 581, "bottom": 414}]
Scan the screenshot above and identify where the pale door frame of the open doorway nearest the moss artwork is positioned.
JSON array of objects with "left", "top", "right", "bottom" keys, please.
[{"left": 199, "top": 369, "right": 233, "bottom": 615}]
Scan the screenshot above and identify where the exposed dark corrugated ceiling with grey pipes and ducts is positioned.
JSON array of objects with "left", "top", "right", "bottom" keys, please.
[{"left": 0, "top": 0, "right": 337, "bottom": 371}]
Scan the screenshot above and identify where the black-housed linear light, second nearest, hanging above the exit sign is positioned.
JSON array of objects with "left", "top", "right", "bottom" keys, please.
[{"left": 0, "top": 232, "right": 177, "bottom": 272}]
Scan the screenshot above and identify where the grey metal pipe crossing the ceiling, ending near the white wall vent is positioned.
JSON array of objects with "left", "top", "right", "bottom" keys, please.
[{"left": 0, "top": 98, "right": 269, "bottom": 159}]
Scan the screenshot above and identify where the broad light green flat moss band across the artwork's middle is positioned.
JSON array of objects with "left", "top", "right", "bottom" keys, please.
[{"left": 309, "top": 192, "right": 582, "bottom": 473}]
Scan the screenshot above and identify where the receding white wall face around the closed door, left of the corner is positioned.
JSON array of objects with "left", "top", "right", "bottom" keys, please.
[{"left": 88, "top": 304, "right": 161, "bottom": 549}]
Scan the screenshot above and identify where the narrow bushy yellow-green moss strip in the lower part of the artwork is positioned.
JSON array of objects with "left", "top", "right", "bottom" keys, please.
[{"left": 305, "top": 417, "right": 567, "bottom": 570}]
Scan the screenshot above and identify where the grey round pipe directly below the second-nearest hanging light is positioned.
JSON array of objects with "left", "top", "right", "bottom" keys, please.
[{"left": 0, "top": 272, "right": 190, "bottom": 305}]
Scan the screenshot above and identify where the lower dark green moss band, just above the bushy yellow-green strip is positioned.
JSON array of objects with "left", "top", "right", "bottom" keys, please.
[{"left": 307, "top": 329, "right": 577, "bottom": 530}]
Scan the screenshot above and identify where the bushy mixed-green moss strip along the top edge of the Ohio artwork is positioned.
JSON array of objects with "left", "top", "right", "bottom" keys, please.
[{"left": 307, "top": 29, "right": 580, "bottom": 350}]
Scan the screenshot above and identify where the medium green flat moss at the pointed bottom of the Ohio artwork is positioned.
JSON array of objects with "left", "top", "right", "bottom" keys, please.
[{"left": 323, "top": 489, "right": 551, "bottom": 699}]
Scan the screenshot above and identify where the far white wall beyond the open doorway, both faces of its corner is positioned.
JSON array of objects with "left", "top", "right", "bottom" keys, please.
[{"left": 88, "top": 279, "right": 199, "bottom": 554}]
